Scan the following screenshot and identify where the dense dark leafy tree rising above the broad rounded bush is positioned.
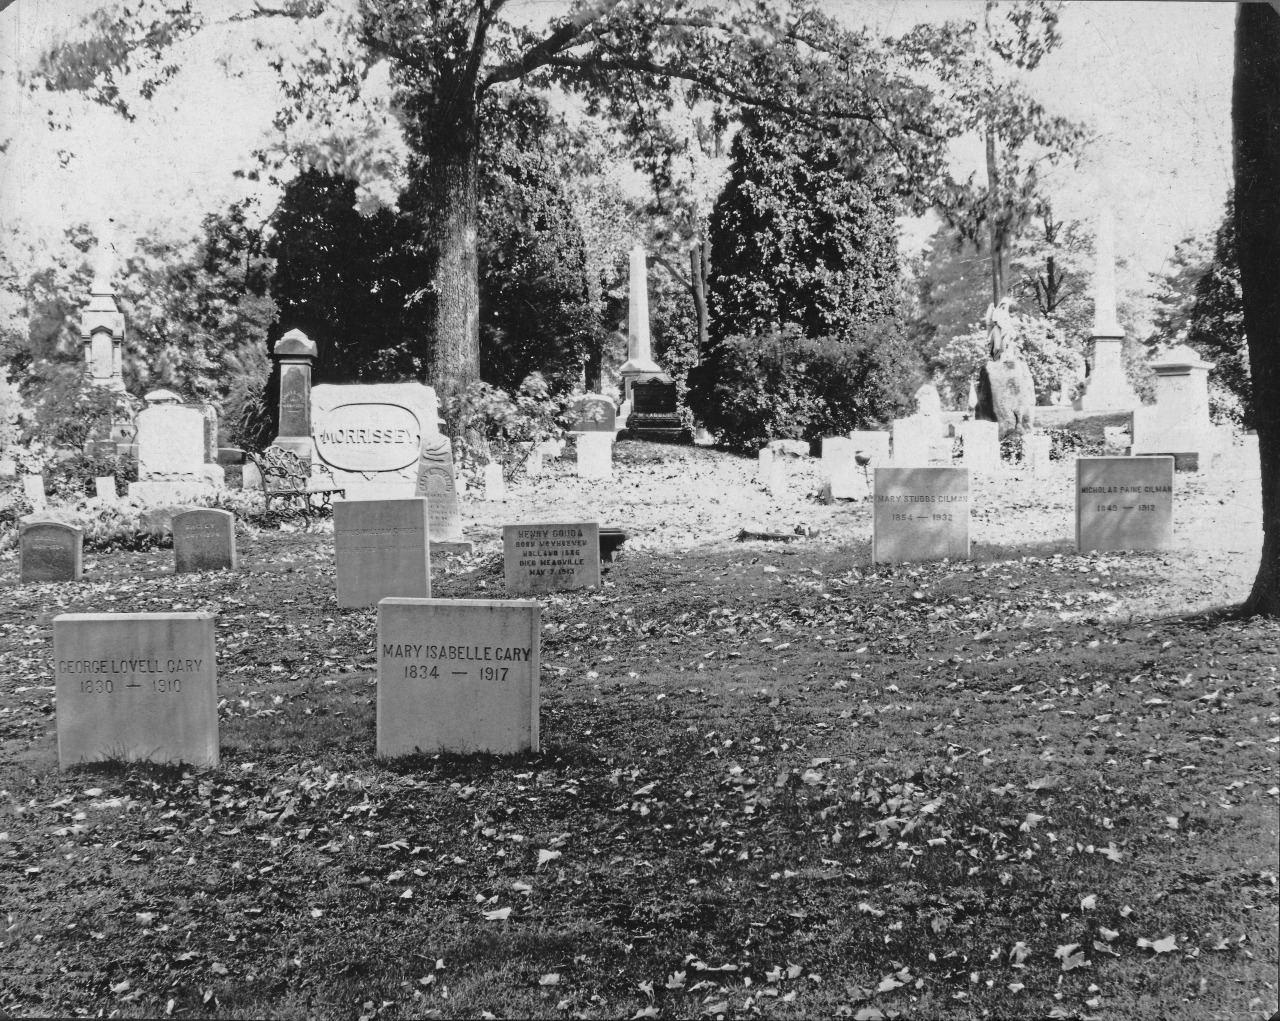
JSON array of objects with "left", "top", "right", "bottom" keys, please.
[{"left": 709, "top": 118, "right": 897, "bottom": 343}]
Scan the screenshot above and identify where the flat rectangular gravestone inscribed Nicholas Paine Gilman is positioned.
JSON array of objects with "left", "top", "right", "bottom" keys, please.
[{"left": 1075, "top": 457, "right": 1174, "bottom": 553}]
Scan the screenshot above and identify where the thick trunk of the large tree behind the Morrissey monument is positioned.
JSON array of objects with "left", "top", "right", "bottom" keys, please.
[{"left": 422, "top": 106, "right": 480, "bottom": 406}]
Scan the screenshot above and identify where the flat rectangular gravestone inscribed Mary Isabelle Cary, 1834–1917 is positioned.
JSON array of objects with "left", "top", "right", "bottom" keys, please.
[{"left": 378, "top": 599, "right": 541, "bottom": 756}]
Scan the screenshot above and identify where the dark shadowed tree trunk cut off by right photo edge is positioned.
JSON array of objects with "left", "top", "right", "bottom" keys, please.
[{"left": 1231, "top": 4, "right": 1280, "bottom": 617}]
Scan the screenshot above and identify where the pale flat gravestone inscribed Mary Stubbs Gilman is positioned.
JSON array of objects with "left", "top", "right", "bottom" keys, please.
[{"left": 872, "top": 468, "right": 969, "bottom": 564}]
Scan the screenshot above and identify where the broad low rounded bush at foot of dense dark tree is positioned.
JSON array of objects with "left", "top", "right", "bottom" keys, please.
[{"left": 689, "top": 320, "right": 919, "bottom": 452}]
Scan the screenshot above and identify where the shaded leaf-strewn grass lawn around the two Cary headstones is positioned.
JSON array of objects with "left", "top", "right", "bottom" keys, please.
[{"left": 0, "top": 450, "right": 1280, "bottom": 1021}]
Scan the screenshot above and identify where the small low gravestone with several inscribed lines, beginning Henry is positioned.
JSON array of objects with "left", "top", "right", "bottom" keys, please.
[{"left": 502, "top": 521, "right": 600, "bottom": 595}]
